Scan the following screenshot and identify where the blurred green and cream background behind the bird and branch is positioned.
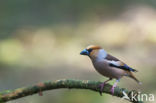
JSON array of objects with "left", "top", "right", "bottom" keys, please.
[{"left": 0, "top": 0, "right": 156, "bottom": 103}]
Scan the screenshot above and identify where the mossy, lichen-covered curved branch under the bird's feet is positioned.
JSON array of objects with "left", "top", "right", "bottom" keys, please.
[{"left": 0, "top": 79, "right": 143, "bottom": 103}]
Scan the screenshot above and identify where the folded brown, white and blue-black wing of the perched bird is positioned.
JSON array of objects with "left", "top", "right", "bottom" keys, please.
[{"left": 105, "top": 54, "right": 137, "bottom": 72}]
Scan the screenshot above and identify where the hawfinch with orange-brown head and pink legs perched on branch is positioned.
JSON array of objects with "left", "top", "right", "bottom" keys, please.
[{"left": 80, "top": 45, "right": 142, "bottom": 95}]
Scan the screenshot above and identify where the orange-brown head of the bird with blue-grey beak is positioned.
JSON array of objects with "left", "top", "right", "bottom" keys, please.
[{"left": 80, "top": 45, "right": 102, "bottom": 57}]
